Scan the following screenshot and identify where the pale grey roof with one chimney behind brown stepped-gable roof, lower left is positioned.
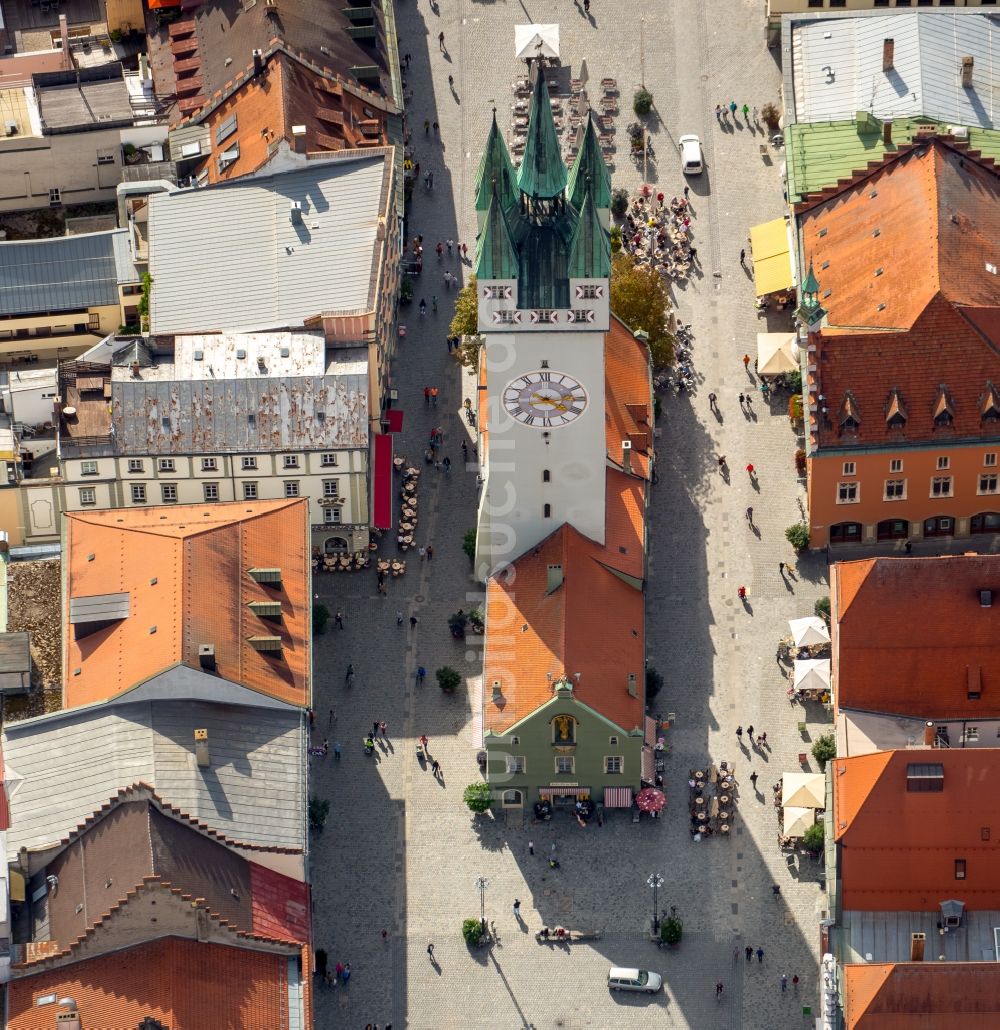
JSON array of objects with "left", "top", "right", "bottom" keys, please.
[{"left": 3, "top": 691, "right": 306, "bottom": 859}]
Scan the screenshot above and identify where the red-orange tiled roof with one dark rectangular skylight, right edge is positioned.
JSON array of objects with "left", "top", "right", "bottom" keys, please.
[{"left": 833, "top": 748, "right": 1000, "bottom": 912}]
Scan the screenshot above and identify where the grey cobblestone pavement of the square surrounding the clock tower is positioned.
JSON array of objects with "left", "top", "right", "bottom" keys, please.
[{"left": 312, "top": 0, "right": 826, "bottom": 1028}]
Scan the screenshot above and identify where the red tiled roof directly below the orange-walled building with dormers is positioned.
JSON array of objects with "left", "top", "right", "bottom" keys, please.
[{"left": 830, "top": 554, "right": 1000, "bottom": 719}]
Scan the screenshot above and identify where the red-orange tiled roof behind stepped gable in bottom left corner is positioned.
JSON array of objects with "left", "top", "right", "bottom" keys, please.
[{"left": 7, "top": 937, "right": 289, "bottom": 1030}]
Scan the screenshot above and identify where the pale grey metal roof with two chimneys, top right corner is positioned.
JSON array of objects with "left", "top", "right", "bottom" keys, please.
[{"left": 792, "top": 10, "right": 1000, "bottom": 129}]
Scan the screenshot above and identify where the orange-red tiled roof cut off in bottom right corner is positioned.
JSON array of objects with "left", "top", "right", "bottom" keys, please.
[{"left": 843, "top": 962, "right": 1000, "bottom": 1030}]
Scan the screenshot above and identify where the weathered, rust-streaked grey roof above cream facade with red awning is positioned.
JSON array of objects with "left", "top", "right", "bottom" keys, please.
[{"left": 111, "top": 370, "right": 368, "bottom": 454}]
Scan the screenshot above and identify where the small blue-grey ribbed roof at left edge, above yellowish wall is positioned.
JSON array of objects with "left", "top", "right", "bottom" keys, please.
[{"left": 0, "top": 229, "right": 131, "bottom": 315}]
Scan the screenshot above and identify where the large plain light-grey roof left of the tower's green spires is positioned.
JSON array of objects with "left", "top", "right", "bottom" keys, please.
[{"left": 149, "top": 151, "right": 395, "bottom": 333}]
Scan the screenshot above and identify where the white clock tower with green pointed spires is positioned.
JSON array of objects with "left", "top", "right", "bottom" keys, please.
[{"left": 476, "top": 64, "right": 611, "bottom": 579}]
